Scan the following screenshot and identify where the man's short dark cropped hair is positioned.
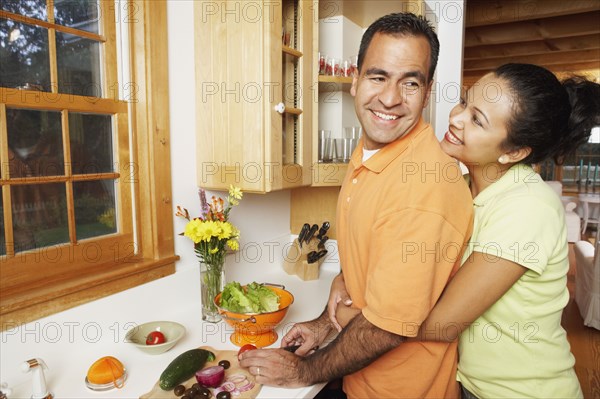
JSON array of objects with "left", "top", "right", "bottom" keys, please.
[{"left": 357, "top": 12, "right": 440, "bottom": 82}]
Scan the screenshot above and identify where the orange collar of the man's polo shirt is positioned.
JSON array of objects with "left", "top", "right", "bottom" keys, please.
[{"left": 350, "top": 118, "right": 428, "bottom": 173}]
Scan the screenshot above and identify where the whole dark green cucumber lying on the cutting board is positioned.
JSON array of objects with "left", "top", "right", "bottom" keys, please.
[{"left": 158, "top": 349, "right": 215, "bottom": 391}]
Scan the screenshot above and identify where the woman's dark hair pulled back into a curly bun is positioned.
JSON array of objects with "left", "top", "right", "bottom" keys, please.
[{"left": 493, "top": 64, "right": 600, "bottom": 165}]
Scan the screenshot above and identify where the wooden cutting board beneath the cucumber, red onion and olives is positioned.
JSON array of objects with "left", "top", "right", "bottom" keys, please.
[{"left": 140, "top": 346, "right": 262, "bottom": 399}]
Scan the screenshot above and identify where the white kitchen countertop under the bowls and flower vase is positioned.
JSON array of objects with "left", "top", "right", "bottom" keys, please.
[{"left": 0, "top": 241, "right": 339, "bottom": 399}]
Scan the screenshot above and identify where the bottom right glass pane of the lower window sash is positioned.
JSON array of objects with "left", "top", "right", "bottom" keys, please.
[{"left": 73, "top": 180, "right": 117, "bottom": 240}]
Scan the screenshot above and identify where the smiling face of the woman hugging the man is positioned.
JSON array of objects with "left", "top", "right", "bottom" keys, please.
[{"left": 441, "top": 74, "right": 513, "bottom": 167}]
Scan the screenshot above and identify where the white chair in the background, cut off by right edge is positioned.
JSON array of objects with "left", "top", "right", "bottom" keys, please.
[{"left": 574, "top": 240, "right": 600, "bottom": 330}]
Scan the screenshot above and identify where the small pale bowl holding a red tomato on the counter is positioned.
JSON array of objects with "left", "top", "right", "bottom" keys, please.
[{"left": 125, "top": 321, "right": 185, "bottom": 355}]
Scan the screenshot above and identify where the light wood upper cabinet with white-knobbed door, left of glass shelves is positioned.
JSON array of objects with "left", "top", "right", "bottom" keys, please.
[{"left": 194, "top": 0, "right": 318, "bottom": 193}]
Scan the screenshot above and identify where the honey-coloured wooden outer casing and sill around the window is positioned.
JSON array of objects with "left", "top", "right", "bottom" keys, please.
[{"left": 0, "top": 0, "right": 178, "bottom": 331}]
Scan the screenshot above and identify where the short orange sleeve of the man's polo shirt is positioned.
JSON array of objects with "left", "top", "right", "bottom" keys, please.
[{"left": 362, "top": 209, "right": 465, "bottom": 337}]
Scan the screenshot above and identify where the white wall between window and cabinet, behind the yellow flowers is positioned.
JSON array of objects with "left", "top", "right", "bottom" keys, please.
[{"left": 167, "top": 1, "right": 290, "bottom": 270}]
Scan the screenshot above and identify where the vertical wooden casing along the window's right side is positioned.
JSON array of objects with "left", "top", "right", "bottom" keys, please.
[{"left": 130, "top": 0, "right": 175, "bottom": 259}]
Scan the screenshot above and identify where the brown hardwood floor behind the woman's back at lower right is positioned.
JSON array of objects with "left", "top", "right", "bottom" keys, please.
[{"left": 562, "top": 242, "right": 600, "bottom": 399}]
